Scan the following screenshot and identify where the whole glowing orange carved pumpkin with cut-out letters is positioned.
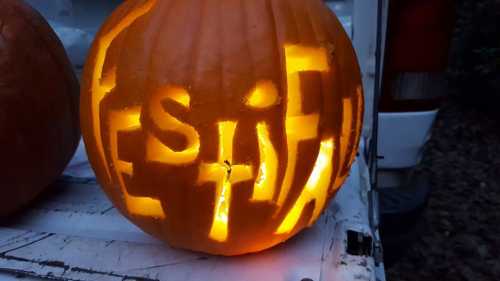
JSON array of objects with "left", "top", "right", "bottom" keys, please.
[{"left": 81, "top": 0, "right": 363, "bottom": 255}]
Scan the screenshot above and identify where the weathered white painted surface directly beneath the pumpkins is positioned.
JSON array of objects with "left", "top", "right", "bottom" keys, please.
[{"left": 0, "top": 158, "right": 375, "bottom": 281}]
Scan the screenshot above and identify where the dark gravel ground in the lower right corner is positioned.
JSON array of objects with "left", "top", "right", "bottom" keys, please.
[{"left": 387, "top": 100, "right": 500, "bottom": 281}]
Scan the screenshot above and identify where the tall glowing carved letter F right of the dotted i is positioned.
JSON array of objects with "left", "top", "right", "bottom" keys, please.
[{"left": 277, "top": 45, "right": 330, "bottom": 206}]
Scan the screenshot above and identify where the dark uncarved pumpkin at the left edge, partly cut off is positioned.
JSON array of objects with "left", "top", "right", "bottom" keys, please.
[{"left": 0, "top": 0, "right": 80, "bottom": 217}]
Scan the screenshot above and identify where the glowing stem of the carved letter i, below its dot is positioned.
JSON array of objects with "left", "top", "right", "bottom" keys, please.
[{"left": 252, "top": 122, "right": 278, "bottom": 201}]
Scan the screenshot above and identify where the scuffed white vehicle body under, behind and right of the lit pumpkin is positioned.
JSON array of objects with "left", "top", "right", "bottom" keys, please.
[{"left": 0, "top": 0, "right": 386, "bottom": 281}]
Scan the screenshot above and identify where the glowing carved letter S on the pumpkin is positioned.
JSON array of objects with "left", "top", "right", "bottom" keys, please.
[{"left": 146, "top": 86, "right": 200, "bottom": 165}]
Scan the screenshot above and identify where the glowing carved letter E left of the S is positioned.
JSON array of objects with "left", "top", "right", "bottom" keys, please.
[{"left": 108, "top": 108, "right": 165, "bottom": 218}]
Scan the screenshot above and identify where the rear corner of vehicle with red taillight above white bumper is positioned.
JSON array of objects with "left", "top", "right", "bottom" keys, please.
[{"left": 377, "top": 0, "right": 455, "bottom": 266}]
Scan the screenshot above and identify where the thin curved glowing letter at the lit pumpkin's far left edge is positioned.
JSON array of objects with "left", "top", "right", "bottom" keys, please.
[{"left": 91, "top": 0, "right": 156, "bottom": 179}]
